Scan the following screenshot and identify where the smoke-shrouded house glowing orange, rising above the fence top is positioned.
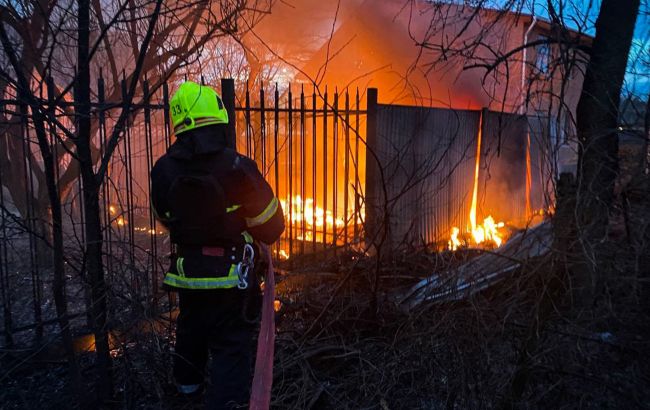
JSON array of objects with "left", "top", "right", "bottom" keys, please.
[{"left": 247, "top": 0, "right": 590, "bottom": 113}]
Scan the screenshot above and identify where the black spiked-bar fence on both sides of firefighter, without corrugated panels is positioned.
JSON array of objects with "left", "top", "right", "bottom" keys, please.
[{"left": 0, "top": 78, "right": 365, "bottom": 345}]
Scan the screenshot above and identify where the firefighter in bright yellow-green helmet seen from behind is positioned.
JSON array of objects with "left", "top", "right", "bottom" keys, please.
[{"left": 151, "top": 81, "right": 284, "bottom": 409}]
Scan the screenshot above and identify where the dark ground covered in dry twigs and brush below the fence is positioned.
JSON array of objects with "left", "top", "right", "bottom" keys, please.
[{"left": 0, "top": 139, "right": 650, "bottom": 410}]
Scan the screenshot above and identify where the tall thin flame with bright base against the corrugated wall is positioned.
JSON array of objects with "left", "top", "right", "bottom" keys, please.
[{"left": 447, "top": 115, "right": 505, "bottom": 251}]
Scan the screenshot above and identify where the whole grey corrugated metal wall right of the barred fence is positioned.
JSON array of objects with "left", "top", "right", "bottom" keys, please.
[{"left": 366, "top": 104, "right": 545, "bottom": 248}]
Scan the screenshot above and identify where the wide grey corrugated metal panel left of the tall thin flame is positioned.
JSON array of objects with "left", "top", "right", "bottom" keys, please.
[{"left": 366, "top": 105, "right": 480, "bottom": 246}]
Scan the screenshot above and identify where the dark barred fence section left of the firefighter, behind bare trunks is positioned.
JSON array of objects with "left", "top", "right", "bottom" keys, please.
[{"left": 0, "top": 78, "right": 170, "bottom": 345}]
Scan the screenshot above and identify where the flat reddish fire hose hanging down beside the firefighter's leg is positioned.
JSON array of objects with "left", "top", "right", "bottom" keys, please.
[{"left": 249, "top": 245, "right": 275, "bottom": 410}]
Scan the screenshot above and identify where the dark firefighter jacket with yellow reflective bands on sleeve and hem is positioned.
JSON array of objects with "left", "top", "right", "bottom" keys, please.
[{"left": 151, "top": 125, "right": 284, "bottom": 289}]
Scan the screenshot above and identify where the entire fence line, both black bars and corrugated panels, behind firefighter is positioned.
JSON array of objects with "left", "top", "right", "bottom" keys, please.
[{"left": 0, "top": 79, "right": 549, "bottom": 344}]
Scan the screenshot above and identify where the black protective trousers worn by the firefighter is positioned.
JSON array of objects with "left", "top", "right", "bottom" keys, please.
[{"left": 174, "top": 281, "right": 261, "bottom": 409}]
